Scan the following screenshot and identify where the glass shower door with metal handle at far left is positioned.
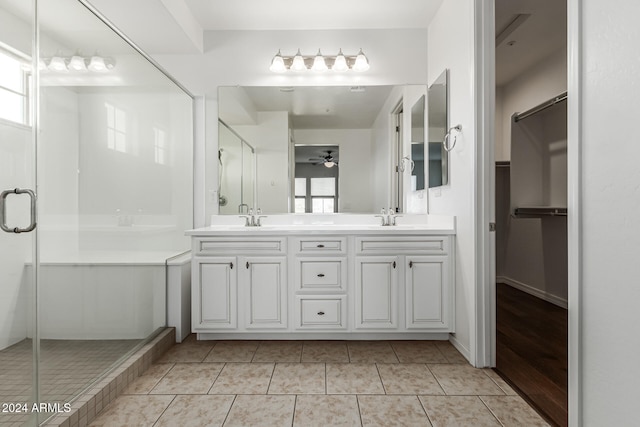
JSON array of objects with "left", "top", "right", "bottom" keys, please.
[{"left": 0, "top": 0, "right": 37, "bottom": 425}]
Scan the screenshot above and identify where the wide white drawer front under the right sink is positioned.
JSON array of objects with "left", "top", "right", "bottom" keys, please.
[{"left": 356, "top": 236, "right": 449, "bottom": 255}]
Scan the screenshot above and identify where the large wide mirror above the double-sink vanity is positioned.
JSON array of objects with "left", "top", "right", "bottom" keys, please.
[{"left": 218, "top": 85, "right": 427, "bottom": 214}]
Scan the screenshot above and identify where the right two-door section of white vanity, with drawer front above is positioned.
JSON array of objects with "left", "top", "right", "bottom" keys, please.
[{"left": 355, "top": 235, "right": 454, "bottom": 332}]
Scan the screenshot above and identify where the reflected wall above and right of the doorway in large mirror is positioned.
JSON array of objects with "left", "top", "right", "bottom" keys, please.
[{"left": 293, "top": 129, "right": 377, "bottom": 213}]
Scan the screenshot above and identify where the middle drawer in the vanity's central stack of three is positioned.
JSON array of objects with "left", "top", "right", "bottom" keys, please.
[{"left": 295, "top": 257, "right": 347, "bottom": 292}]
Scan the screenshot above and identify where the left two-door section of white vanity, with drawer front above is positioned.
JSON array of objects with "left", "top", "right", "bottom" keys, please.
[{"left": 191, "top": 237, "right": 288, "bottom": 332}]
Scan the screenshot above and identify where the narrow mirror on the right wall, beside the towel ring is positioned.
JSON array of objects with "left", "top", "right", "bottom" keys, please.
[{"left": 427, "top": 70, "right": 449, "bottom": 188}]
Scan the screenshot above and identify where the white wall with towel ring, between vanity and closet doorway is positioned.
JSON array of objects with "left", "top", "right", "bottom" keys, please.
[{"left": 428, "top": 0, "right": 479, "bottom": 363}]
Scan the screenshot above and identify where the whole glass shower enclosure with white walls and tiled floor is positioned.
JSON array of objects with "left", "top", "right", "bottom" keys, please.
[{"left": 0, "top": 0, "right": 193, "bottom": 425}]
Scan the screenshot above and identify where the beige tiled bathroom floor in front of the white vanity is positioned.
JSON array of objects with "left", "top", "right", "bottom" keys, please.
[{"left": 92, "top": 335, "right": 548, "bottom": 427}]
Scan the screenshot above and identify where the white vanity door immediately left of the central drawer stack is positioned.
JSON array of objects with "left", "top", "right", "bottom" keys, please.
[{"left": 238, "top": 257, "right": 287, "bottom": 329}]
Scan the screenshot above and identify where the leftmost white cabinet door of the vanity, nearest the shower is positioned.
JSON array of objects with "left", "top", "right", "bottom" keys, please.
[{"left": 192, "top": 257, "right": 238, "bottom": 332}]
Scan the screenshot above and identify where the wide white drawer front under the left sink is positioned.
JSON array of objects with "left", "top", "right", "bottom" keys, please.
[{"left": 194, "top": 237, "right": 287, "bottom": 255}]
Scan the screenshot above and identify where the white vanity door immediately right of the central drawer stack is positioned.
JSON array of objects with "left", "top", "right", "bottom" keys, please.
[{"left": 355, "top": 256, "right": 399, "bottom": 329}]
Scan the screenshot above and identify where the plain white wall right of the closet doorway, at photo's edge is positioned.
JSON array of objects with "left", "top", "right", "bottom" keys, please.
[{"left": 569, "top": 0, "right": 640, "bottom": 427}]
